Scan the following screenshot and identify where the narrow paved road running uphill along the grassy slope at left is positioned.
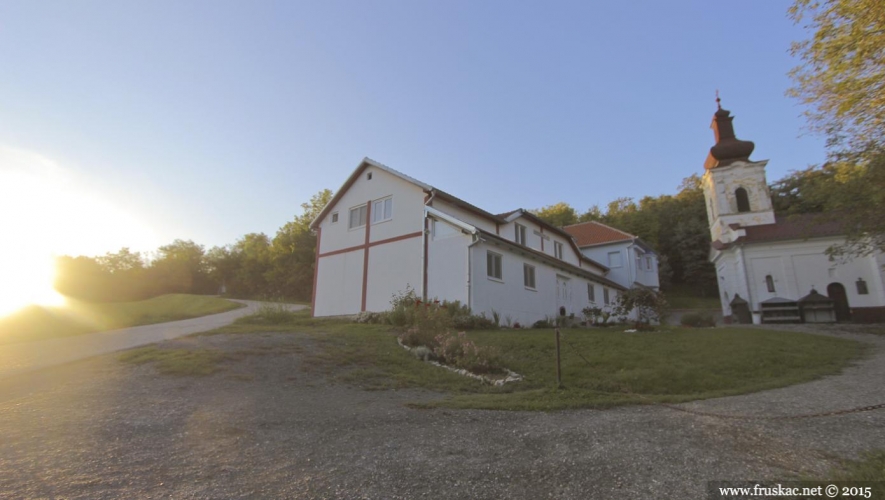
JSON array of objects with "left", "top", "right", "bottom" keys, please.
[{"left": 0, "top": 300, "right": 307, "bottom": 378}]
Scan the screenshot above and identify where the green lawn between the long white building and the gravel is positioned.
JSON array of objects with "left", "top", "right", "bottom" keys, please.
[{"left": 207, "top": 312, "right": 865, "bottom": 410}]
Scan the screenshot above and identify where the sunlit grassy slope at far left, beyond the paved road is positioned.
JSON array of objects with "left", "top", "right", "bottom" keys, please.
[{"left": 0, "top": 294, "right": 242, "bottom": 345}]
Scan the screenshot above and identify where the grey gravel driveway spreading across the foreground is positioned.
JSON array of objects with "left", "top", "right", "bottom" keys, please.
[{"left": 0, "top": 322, "right": 885, "bottom": 499}]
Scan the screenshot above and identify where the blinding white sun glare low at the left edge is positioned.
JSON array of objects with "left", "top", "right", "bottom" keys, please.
[{"left": 0, "top": 146, "right": 153, "bottom": 316}]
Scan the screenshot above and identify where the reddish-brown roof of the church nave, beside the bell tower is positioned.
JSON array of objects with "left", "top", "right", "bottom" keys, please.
[{"left": 713, "top": 214, "right": 845, "bottom": 250}]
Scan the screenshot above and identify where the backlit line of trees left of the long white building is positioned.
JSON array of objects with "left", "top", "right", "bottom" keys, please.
[{"left": 55, "top": 189, "right": 332, "bottom": 301}]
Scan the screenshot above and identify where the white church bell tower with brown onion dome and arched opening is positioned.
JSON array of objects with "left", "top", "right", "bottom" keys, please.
[{"left": 703, "top": 96, "right": 774, "bottom": 243}]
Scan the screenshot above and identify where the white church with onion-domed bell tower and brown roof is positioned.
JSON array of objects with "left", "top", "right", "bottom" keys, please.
[{"left": 703, "top": 103, "right": 885, "bottom": 323}]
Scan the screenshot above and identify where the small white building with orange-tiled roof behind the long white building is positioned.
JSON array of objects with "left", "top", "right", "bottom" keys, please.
[{"left": 563, "top": 222, "right": 661, "bottom": 290}]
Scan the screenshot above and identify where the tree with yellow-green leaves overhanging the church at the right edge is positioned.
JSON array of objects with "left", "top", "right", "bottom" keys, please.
[{"left": 779, "top": 0, "right": 885, "bottom": 257}]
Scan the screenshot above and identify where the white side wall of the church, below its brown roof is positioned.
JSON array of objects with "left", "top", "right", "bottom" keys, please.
[{"left": 714, "top": 238, "right": 885, "bottom": 315}]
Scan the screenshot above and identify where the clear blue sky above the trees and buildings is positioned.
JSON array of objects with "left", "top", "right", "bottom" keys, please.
[{"left": 0, "top": 0, "right": 824, "bottom": 253}]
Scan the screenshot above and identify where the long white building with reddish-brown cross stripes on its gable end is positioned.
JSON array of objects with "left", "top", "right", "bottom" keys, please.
[{"left": 311, "top": 158, "right": 624, "bottom": 326}]
